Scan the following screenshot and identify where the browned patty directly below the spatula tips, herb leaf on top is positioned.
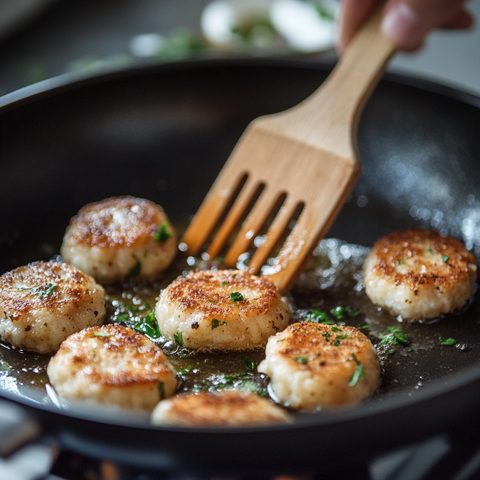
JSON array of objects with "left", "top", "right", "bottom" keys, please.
[{"left": 155, "top": 270, "right": 290, "bottom": 351}]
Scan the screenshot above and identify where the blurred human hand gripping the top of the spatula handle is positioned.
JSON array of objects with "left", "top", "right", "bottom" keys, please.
[{"left": 339, "top": 0, "right": 473, "bottom": 51}]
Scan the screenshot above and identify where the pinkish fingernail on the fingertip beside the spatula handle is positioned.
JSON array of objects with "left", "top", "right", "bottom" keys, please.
[{"left": 382, "top": 2, "right": 422, "bottom": 46}]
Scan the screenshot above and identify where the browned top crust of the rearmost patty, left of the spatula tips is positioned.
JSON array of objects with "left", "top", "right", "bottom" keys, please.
[{"left": 63, "top": 196, "right": 169, "bottom": 248}]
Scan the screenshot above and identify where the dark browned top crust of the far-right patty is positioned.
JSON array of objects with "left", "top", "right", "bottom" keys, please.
[{"left": 372, "top": 228, "right": 476, "bottom": 289}]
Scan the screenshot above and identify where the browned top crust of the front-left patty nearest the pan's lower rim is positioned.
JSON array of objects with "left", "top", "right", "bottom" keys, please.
[{"left": 58, "top": 325, "right": 172, "bottom": 387}]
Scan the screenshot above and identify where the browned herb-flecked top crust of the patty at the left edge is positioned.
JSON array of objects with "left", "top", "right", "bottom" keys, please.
[{"left": 0, "top": 261, "right": 99, "bottom": 321}]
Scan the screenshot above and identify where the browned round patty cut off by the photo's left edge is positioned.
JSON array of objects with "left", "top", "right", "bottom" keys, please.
[{"left": 0, "top": 262, "right": 105, "bottom": 354}]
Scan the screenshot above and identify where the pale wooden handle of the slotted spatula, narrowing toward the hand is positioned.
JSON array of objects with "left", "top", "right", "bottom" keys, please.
[{"left": 264, "top": 5, "right": 395, "bottom": 161}]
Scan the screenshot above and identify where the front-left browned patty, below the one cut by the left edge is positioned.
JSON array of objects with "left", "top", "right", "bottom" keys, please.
[{"left": 47, "top": 325, "right": 177, "bottom": 410}]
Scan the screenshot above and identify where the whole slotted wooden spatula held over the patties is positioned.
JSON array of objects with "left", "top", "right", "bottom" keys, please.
[{"left": 181, "top": 8, "right": 395, "bottom": 293}]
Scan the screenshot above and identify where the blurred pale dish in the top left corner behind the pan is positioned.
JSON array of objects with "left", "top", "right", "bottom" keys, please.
[{"left": 0, "top": 0, "right": 55, "bottom": 40}]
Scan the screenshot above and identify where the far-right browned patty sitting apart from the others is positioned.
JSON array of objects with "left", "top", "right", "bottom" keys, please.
[{"left": 363, "top": 229, "right": 477, "bottom": 320}]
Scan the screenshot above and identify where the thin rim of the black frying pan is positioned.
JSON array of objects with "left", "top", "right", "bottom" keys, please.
[{"left": 0, "top": 57, "right": 480, "bottom": 434}]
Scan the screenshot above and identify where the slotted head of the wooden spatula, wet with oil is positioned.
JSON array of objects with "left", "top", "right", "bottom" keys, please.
[{"left": 182, "top": 116, "right": 360, "bottom": 292}]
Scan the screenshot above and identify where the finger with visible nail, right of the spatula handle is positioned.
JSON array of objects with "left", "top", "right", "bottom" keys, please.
[{"left": 382, "top": 0, "right": 472, "bottom": 51}]
